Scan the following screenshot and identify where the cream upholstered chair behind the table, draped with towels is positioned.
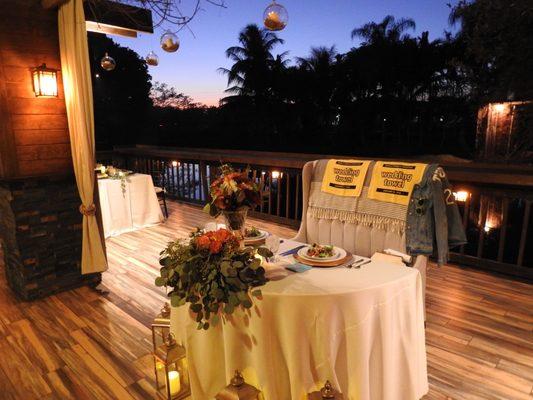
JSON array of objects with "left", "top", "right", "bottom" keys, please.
[{"left": 293, "top": 161, "right": 428, "bottom": 311}]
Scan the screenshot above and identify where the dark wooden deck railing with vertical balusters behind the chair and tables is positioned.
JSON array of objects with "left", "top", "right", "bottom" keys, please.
[{"left": 97, "top": 146, "right": 533, "bottom": 279}]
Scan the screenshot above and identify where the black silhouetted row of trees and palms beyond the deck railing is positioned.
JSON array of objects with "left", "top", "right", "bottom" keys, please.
[{"left": 152, "top": 21, "right": 477, "bottom": 157}]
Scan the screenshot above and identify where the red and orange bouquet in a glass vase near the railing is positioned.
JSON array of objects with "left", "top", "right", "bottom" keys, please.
[{"left": 204, "top": 164, "right": 261, "bottom": 239}]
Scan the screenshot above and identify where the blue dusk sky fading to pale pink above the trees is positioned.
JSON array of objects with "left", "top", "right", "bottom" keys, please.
[{"left": 113, "top": 0, "right": 451, "bottom": 105}]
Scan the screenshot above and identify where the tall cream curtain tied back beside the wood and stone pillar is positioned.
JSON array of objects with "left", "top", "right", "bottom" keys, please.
[{"left": 58, "top": 0, "right": 107, "bottom": 274}]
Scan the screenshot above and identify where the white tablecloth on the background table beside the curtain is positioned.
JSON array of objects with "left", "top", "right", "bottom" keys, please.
[{"left": 98, "top": 174, "right": 164, "bottom": 238}]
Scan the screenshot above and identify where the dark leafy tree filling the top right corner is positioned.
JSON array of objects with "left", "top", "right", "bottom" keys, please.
[{"left": 450, "top": 0, "right": 533, "bottom": 102}]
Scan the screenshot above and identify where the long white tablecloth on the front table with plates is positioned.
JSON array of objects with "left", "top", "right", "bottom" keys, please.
[{"left": 171, "top": 241, "right": 428, "bottom": 400}]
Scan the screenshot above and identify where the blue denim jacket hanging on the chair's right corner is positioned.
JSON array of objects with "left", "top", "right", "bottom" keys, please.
[{"left": 406, "top": 164, "right": 466, "bottom": 265}]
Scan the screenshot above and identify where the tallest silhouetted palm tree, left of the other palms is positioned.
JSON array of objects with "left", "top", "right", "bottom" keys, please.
[{"left": 219, "top": 24, "right": 286, "bottom": 102}]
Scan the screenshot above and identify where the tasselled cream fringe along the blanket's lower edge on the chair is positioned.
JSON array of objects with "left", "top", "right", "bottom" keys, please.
[{"left": 307, "top": 206, "right": 405, "bottom": 235}]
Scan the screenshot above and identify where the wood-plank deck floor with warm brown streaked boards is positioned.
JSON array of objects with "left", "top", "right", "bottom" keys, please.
[{"left": 0, "top": 203, "right": 533, "bottom": 400}]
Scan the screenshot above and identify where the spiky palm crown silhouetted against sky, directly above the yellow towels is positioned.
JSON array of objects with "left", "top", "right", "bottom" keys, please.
[{"left": 352, "top": 15, "right": 416, "bottom": 44}]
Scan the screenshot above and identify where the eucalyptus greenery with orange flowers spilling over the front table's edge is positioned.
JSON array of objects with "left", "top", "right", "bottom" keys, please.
[{"left": 155, "top": 229, "right": 272, "bottom": 329}]
